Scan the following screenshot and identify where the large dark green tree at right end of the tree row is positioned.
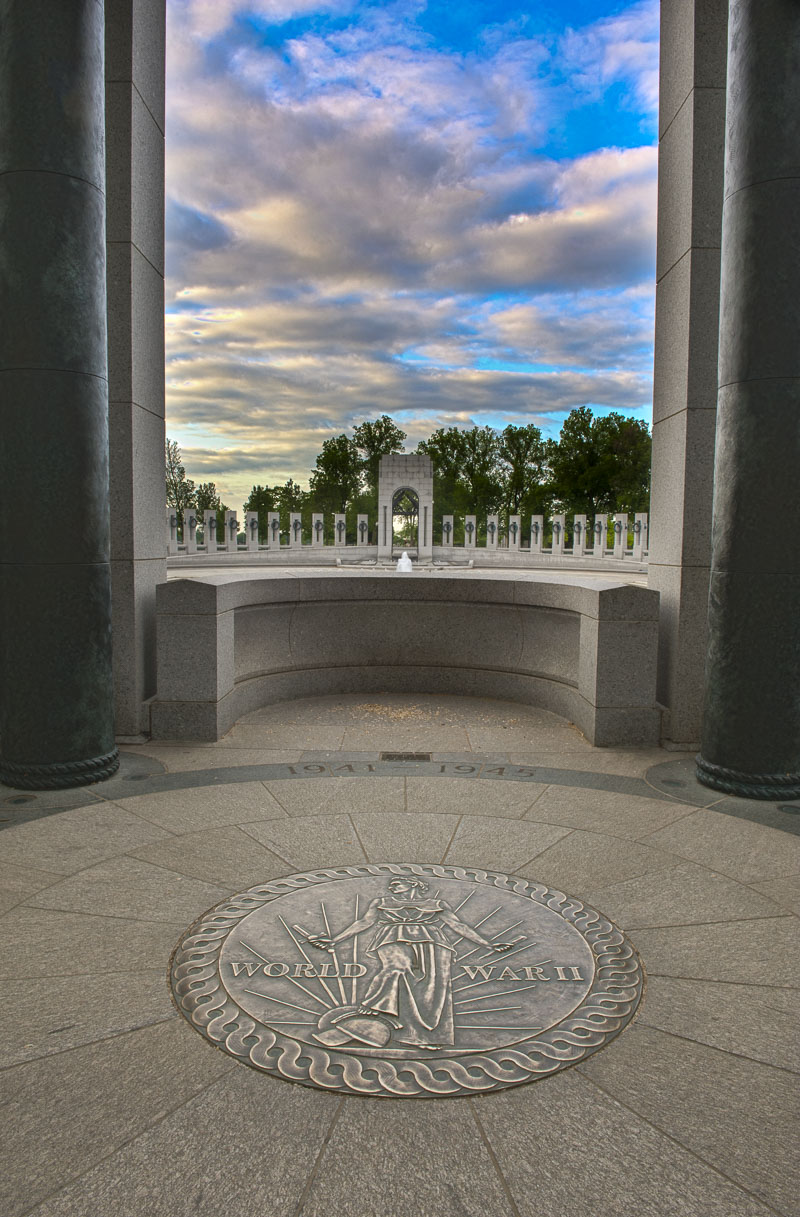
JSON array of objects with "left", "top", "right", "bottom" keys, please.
[{"left": 547, "top": 405, "right": 651, "bottom": 516}]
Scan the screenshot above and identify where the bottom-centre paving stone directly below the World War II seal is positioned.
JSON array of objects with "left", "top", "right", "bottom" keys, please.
[{"left": 302, "top": 1099, "right": 514, "bottom": 1217}]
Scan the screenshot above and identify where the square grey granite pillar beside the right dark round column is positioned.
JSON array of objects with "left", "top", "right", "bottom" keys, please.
[{"left": 648, "top": 0, "right": 728, "bottom": 748}]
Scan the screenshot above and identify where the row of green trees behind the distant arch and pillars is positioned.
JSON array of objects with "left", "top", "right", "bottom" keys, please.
[{"left": 167, "top": 406, "right": 651, "bottom": 540}]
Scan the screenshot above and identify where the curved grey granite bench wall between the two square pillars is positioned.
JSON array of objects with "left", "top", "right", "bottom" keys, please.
[{"left": 151, "top": 570, "right": 660, "bottom": 745}]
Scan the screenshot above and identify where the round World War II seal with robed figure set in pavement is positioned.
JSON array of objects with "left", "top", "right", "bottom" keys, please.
[{"left": 170, "top": 863, "right": 643, "bottom": 1098}]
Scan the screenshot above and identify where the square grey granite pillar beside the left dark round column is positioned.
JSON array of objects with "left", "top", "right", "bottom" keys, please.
[{"left": 105, "top": 0, "right": 167, "bottom": 739}]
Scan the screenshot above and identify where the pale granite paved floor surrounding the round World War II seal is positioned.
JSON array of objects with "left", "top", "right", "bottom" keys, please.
[{"left": 0, "top": 695, "right": 800, "bottom": 1217}]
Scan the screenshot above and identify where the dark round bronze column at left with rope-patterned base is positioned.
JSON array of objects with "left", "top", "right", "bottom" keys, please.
[{"left": 0, "top": 0, "right": 118, "bottom": 789}]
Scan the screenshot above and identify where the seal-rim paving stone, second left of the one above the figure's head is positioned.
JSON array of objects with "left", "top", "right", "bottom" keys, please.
[{"left": 134, "top": 824, "right": 292, "bottom": 893}]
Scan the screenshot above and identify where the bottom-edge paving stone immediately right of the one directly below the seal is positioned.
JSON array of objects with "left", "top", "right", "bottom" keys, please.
[{"left": 470, "top": 1070, "right": 772, "bottom": 1217}]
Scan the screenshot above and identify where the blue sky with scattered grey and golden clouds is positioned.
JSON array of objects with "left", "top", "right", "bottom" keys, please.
[{"left": 166, "top": 0, "right": 659, "bottom": 509}]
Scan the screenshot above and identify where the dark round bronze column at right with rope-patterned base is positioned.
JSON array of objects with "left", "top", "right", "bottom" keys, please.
[{"left": 698, "top": 0, "right": 800, "bottom": 800}]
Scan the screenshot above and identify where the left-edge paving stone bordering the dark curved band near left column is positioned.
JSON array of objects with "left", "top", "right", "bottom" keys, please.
[{"left": 2, "top": 800, "right": 169, "bottom": 875}]
